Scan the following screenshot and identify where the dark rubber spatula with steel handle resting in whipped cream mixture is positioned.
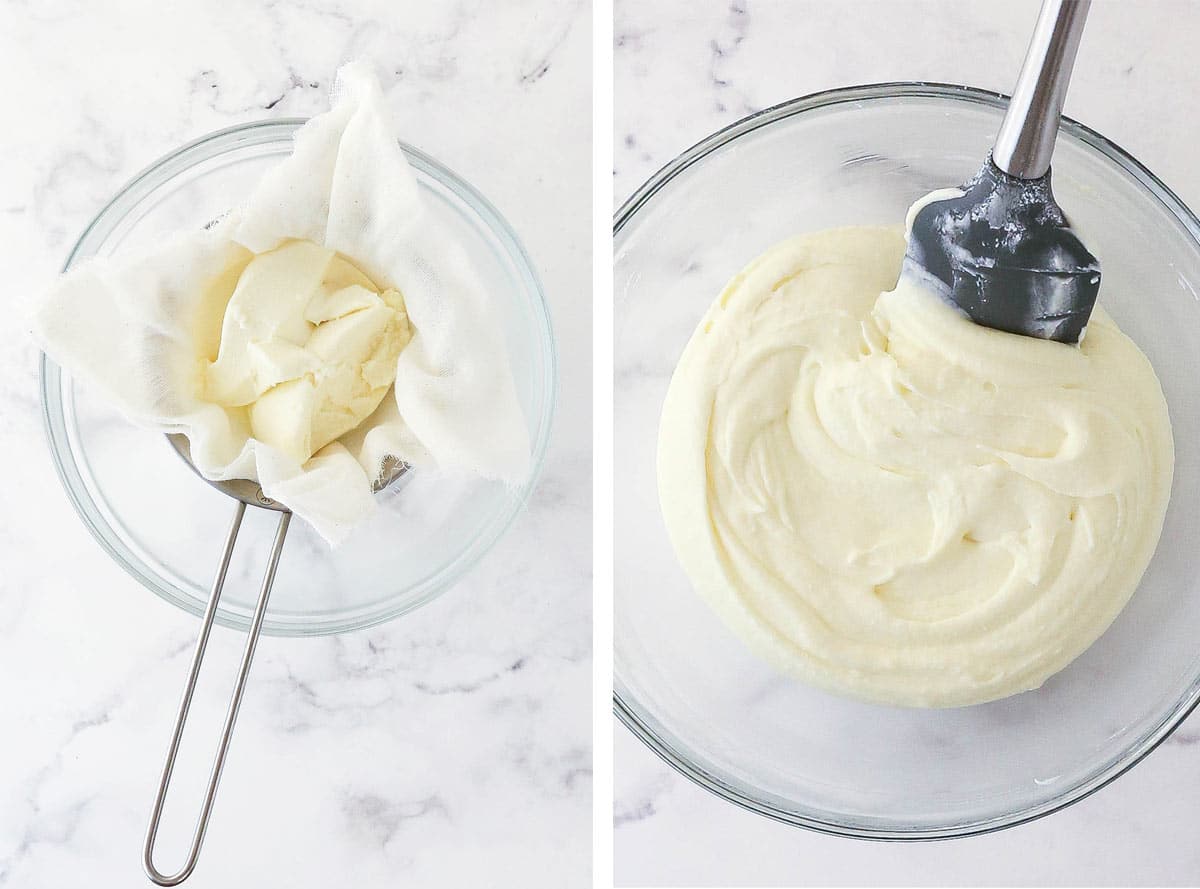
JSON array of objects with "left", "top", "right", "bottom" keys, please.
[{"left": 902, "top": 0, "right": 1100, "bottom": 343}]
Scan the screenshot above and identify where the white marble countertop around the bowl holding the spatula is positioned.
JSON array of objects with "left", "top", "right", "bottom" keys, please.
[{"left": 613, "top": 0, "right": 1200, "bottom": 887}]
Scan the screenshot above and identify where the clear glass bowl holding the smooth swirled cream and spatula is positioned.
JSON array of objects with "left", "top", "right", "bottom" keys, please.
[{"left": 613, "top": 84, "right": 1200, "bottom": 840}]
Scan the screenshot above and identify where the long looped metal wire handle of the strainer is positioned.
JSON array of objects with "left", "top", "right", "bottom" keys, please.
[{"left": 142, "top": 501, "right": 292, "bottom": 885}]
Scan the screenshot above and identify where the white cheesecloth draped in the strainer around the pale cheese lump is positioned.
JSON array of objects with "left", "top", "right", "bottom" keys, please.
[{"left": 32, "top": 64, "right": 530, "bottom": 545}]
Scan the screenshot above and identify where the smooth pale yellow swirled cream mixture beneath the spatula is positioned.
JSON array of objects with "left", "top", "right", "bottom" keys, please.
[{"left": 659, "top": 227, "right": 1174, "bottom": 707}]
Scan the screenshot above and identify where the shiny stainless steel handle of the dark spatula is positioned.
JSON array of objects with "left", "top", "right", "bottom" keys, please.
[{"left": 991, "top": 0, "right": 1092, "bottom": 179}]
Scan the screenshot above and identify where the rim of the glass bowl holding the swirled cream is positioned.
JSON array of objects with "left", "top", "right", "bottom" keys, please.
[{"left": 613, "top": 80, "right": 1200, "bottom": 842}]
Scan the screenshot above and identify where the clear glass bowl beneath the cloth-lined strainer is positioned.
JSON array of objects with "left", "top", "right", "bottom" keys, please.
[{"left": 42, "top": 120, "right": 556, "bottom": 636}]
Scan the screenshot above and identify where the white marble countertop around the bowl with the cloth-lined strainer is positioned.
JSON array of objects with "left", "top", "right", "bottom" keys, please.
[{"left": 0, "top": 0, "right": 592, "bottom": 889}]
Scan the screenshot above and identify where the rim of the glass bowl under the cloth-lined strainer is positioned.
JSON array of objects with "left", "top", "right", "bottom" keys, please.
[{"left": 38, "top": 118, "right": 558, "bottom": 636}]
